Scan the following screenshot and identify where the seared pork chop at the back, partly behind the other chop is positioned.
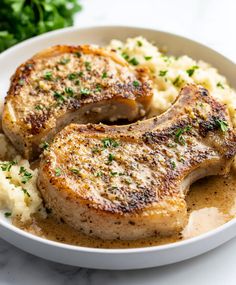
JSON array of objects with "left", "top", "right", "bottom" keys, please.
[{"left": 3, "top": 45, "right": 152, "bottom": 160}]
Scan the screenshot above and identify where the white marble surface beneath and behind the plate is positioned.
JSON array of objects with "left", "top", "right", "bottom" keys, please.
[{"left": 0, "top": 0, "right": 236, "bottom": 285}]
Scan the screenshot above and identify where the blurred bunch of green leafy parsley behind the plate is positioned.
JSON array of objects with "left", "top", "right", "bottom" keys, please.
[{"left": 0, "top": 0, "right": 81, "bottom": 52}]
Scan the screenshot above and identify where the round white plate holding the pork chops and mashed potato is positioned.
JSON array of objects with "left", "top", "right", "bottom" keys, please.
[{"left": 0, "top": 27, "right": 236, "bottom": 269}]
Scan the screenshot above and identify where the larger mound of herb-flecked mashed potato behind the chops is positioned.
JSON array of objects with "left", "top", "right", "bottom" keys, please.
[{"left": 108, "top": 37, "right": 236, "bottom": 127}]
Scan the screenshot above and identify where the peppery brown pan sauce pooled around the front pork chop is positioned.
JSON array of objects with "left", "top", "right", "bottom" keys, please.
[{"left": 15, "top": 173, "right": 236, "bottom": 248}]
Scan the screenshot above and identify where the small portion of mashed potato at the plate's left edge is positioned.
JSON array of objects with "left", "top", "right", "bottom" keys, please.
[{"left": 0, "top": 134, "right": 45, "bottom": 222}]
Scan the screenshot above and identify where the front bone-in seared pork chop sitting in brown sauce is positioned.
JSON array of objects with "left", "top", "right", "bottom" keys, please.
[{"left": 38, "top": 85, "right": 236, "bottom": 240}]
